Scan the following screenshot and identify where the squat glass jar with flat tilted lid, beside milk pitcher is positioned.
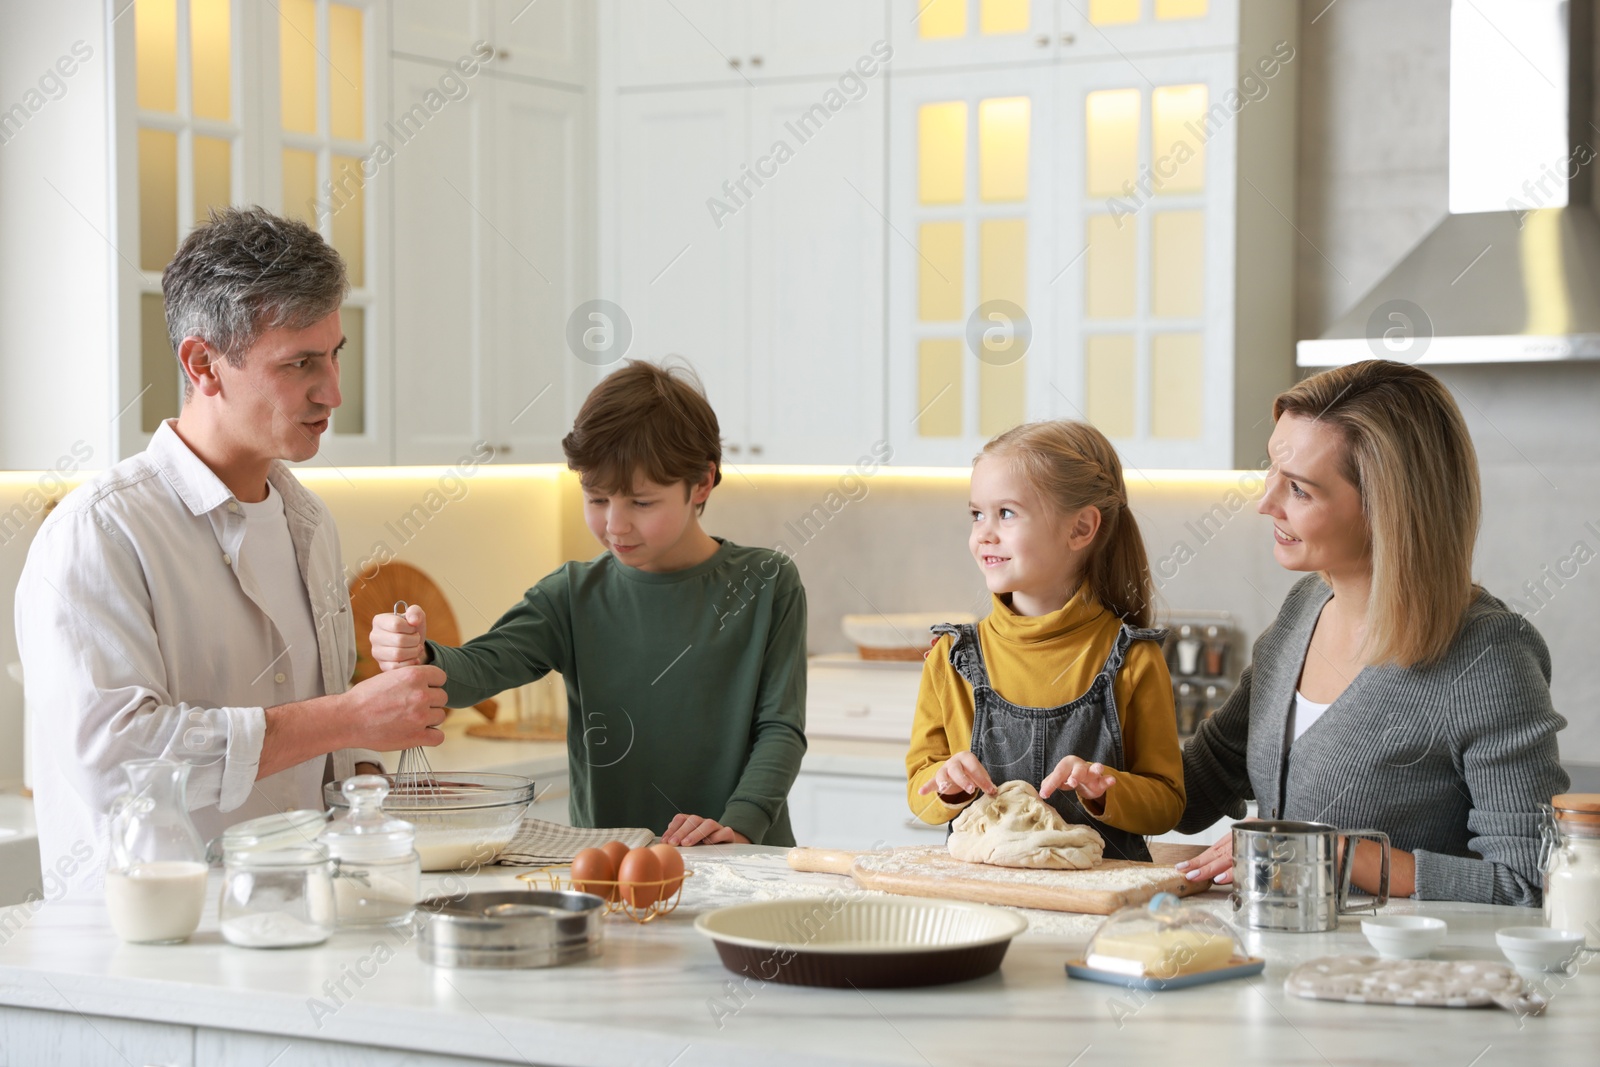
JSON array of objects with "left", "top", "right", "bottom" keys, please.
[{"left": 218, "top": 809, "right": 338, "bottom": 949}]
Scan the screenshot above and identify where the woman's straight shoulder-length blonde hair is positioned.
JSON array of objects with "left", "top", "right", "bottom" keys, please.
[{"left": 1272, "top": 360, "right": 1482, "bottom": 667}]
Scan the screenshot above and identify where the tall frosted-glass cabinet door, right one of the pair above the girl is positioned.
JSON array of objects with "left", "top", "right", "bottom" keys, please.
[{"left": 1051, "top": 53, "right": 1235, "bottom": 467}]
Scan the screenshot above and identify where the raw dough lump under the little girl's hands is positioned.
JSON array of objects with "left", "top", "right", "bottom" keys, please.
[{"left": 950, "top": 781, "right": 1106, "bottom": 870}]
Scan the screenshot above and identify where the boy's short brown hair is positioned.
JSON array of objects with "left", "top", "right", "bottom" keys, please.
[{"left": 562, "top": 360, "right": 722, "bottom": 512}]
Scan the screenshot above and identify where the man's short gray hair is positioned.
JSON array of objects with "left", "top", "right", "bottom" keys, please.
[{"left": 162, "top": 208, "right": 350, "bottom": 388}]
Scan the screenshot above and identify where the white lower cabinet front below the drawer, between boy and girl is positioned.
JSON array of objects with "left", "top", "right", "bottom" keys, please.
[{"left": 789, "top": 773, "right": 946, "bottom": 849}]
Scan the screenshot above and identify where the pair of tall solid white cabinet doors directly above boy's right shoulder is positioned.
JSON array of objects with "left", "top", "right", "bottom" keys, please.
[{"left": 606, "top": 72, "right": 886, "bottom": 464}]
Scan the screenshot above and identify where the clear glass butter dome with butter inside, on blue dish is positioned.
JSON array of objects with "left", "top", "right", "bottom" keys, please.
[{"left": 1083, "top": 893, "right": 1250, "bottom": 979}]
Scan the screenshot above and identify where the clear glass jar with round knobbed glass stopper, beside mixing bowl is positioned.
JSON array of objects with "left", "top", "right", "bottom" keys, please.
[{"left": 322, "top": 774, "right": 422, "bottom": 926}]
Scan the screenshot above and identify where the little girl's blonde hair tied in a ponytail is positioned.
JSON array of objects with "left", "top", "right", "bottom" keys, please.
[{"left": 973, "top": 419, "right": 1155, "bottom": 627}]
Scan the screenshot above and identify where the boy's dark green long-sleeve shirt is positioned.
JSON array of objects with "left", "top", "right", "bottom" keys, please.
[{"left": 427, "top": 539, "right": 806, "bottom": 845}]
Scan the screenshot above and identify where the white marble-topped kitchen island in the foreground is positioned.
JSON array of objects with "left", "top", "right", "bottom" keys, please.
[{"left": 0, "top": 846, "right": 1600, "bottom": 1067}]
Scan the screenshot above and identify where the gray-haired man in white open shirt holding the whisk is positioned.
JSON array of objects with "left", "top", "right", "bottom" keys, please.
[{"left": 16, "top": 208, "right": 445, "bottom": 885}]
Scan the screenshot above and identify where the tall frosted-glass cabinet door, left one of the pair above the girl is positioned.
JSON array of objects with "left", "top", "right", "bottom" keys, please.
[{"left": 886, "top": 66, "right": 1061, "bottom": 466}]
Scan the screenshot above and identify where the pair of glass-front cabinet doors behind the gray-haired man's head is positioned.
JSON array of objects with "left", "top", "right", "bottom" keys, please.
[{"left": 112, "top": 0, "right": 389, "bottom": 462}]
